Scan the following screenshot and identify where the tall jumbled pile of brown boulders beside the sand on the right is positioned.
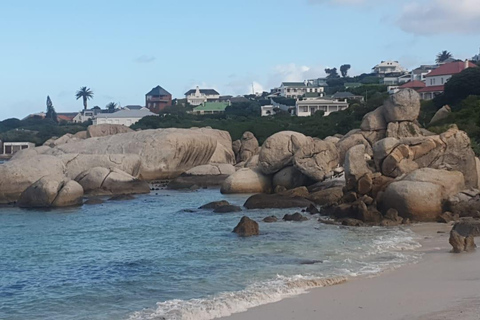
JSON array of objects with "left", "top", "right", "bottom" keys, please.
[{"left": 221, "top": 89, "right": 480, "bottom": 226}]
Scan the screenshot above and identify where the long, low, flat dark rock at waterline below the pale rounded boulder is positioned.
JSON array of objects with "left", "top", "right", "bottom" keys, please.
[{"left": 243, "top": 194, "right": 314, "bottom": 209}]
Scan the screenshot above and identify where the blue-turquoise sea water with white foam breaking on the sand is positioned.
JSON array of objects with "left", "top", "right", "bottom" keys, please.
[{"left": 0, "top": 190, "right": 418, "bottom": 320}]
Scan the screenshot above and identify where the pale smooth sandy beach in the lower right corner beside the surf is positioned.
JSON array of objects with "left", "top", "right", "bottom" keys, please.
[{"left": 222, "top": 223, "right": 480, "bottom": 320}]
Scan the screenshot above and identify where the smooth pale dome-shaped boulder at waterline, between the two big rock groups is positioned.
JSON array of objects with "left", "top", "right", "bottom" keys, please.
[{"left": 220, "top": 168, "right": 272, "bottom": 194}]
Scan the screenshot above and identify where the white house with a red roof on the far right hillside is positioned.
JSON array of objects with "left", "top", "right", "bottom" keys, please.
[{"left": 418, "top": 60, "right": 477, "bottom": 100}]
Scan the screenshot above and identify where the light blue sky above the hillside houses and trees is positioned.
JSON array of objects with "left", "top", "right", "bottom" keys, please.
[{"left": 0, "top": 0, "right": 480, "bottom": 120}]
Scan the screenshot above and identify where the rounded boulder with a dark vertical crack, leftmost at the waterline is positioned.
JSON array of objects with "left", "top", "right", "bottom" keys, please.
[{"left": 17, "top": 175, "right": 83, "bottom": 208}]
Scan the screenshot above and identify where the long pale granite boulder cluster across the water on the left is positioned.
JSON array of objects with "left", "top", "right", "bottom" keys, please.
[{"left": 0, "top": 125, "right": 236, "bottom": 207}]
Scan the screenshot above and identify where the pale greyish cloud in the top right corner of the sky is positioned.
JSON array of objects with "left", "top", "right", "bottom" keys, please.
[{"left": 397, "top": 0, "right": 480, "bottom": 35}]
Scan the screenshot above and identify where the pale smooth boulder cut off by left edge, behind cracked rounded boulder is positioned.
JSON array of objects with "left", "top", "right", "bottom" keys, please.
[{"left": 0, "top": 155, "right": 65, "bottom": 204}]
